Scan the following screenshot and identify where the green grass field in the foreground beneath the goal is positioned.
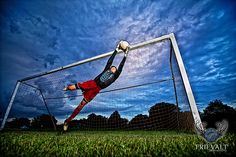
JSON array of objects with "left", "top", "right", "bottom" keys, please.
[{"left": 0, "top": 131, "right": 236, "bottom": 157}]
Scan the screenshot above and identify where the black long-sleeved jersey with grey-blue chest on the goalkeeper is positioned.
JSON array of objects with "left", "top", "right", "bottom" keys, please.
[{"left": 94, "top": 50, "right": 126, "bottom": 89}]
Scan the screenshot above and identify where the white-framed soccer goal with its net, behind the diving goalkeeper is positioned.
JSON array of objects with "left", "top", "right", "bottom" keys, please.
[{"left": 1, "top": 34, "right": 201, "bottom": 130}]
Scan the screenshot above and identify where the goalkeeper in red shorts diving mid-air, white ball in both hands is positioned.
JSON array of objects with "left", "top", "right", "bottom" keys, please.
[{"left": 63, "top": 41, "right": 129, "bottom": 131}]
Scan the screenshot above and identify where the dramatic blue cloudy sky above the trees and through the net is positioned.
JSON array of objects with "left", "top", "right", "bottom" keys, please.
[{"left": 0, "top": 0, "right": 236, "bottom": 121}]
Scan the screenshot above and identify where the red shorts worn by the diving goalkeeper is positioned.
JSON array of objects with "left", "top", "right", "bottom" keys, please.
[{"left": 77, "top": 80, "right": 101, "bottom": 102}]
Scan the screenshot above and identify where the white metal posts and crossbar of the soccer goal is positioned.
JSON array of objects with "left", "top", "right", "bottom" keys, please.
[{"left": 1, "top": 33, "right": 203, "bottom": 129}]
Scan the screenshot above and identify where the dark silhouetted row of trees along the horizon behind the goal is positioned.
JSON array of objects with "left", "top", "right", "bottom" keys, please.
[{"left": 3, "top": 100, "right": 236, "bottom": 131}]
